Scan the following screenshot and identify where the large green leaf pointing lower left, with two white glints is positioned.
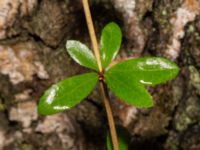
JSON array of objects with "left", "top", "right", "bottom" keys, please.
[{"left": 38, "top": 73, "right": 98, "bottom": 115}]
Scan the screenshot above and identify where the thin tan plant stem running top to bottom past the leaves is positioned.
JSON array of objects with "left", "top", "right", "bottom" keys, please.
[{"left": 82, "top": 0, "right": 119, "bottom": 150}]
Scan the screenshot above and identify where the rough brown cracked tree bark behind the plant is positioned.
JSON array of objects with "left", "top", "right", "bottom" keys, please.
[{"left": 0, "top": 0, "right": 200, "bottom": 150}]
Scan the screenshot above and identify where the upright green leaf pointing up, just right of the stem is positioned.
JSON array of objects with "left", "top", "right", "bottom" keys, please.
[{"left": 100, "top": 22, "right": 122, "bottom": 68}]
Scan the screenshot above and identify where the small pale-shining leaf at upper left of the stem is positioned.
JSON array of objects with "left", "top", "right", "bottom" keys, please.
[{"left": 66, "top": 40, "right": 98, "bottom": 70}]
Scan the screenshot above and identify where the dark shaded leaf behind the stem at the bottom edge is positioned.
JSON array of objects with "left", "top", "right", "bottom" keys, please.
[{"left": 106, "top": 127, "right": 129, "bottom": 150}]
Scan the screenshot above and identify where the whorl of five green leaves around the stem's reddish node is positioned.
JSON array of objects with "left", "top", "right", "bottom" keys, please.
[{"left": 38, "top": 22, "right": 179, "bottom": 115}]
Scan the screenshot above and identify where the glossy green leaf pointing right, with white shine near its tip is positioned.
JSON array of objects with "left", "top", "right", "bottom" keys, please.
[{"left": 108, "top": 57, "right": 179, "bottom": 85}]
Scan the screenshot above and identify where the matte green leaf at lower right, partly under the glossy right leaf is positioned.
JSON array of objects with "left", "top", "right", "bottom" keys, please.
[{"left": 104, "top": 71, "right": 153, "bottom": 108}]
